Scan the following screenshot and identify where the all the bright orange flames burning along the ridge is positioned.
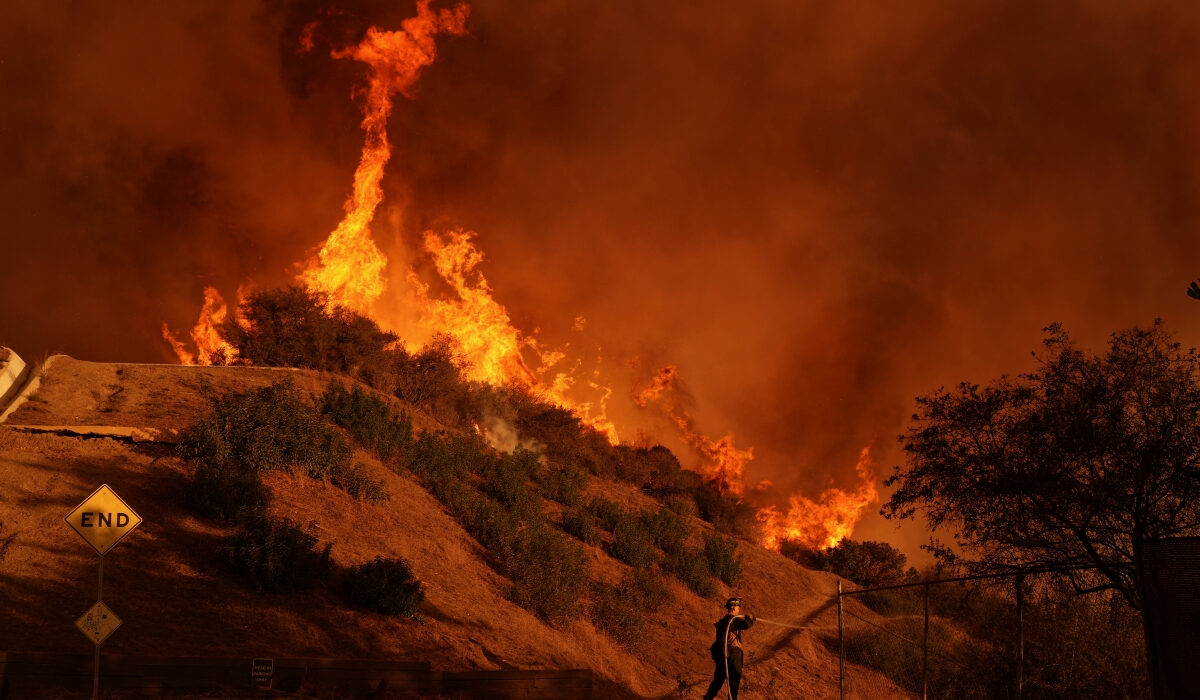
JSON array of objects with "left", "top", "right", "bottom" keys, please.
[{"left": 163, "top": 0, "right": 877, "bottom": 549}]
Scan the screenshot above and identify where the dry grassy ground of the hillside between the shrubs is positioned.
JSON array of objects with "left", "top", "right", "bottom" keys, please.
[{"left": 0, "top": 355, "right": 907, "bottom": 699}]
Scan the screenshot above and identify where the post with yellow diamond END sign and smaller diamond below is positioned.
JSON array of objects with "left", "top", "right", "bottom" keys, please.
[{"left": 65, "top": 484, "right": 142, "bottom": 700}]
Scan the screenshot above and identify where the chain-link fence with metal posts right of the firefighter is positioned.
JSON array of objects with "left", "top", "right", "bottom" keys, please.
[{"left": 835, "top": 574, "right": 1148, "bottom": 700}]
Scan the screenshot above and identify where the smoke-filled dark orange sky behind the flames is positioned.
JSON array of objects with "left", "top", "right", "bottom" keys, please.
[{"left": 0, "top": 0, "right": 1200, "bottom": 559}]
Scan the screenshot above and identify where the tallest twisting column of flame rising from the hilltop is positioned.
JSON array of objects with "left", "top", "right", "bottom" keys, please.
[{"left": 300, "top": 0, "right": 468, "bottom": 316}]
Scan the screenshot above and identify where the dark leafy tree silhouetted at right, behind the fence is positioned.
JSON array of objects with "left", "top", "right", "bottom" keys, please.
[{"left": 883, "top": 322, "right": 1200, "bottom": 691}]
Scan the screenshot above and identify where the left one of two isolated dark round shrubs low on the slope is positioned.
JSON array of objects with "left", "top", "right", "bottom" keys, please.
[{"left": 226, "top": 519, "right": 331, "bottom": 593}]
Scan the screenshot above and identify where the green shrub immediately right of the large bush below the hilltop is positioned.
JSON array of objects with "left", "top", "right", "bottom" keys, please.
[{"left": 320, "top": 379, "right": 413, "bottom": 462}]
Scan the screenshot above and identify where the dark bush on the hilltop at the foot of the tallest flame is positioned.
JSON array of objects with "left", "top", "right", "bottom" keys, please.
[{"left": 220, "top": 286, "right": 397, "bottom": 373}]
